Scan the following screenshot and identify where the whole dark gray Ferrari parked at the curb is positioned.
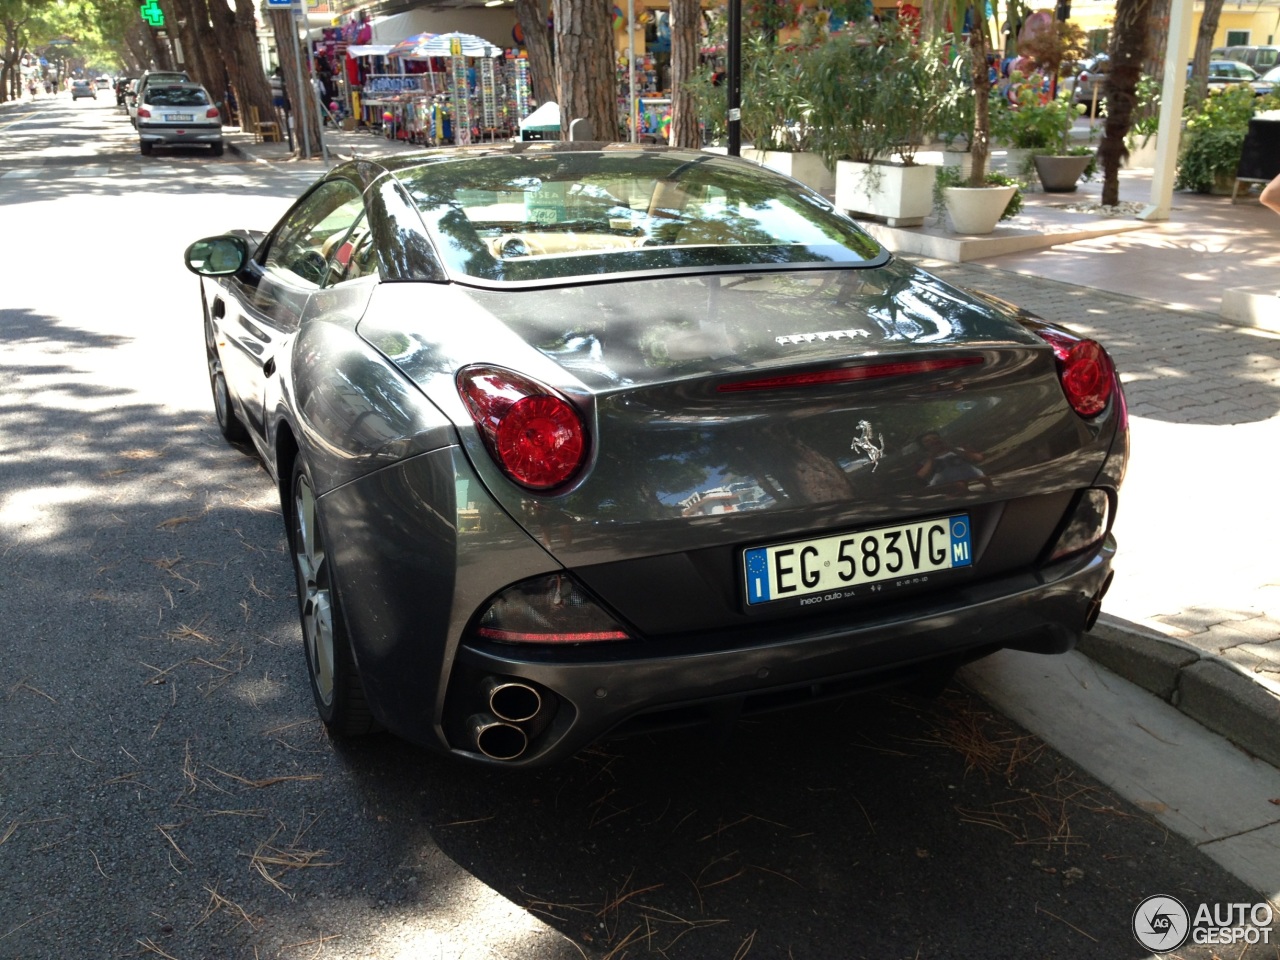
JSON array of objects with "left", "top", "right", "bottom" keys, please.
[{"left": 186, "top": 143, "right": 1128, "bottom": 767}]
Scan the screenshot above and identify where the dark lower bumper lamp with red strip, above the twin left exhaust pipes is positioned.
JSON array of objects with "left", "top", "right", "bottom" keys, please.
[{"left": 476, "top": 573, "right": 631, "bottom": 644}]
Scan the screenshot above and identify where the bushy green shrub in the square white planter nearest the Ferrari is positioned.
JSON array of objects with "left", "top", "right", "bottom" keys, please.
[{"left": 804, "top": 22, "right": 960, "bottom": 227}]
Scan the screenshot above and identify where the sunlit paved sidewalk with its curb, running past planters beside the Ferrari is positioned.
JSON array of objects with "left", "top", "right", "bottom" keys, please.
[{"left": 228, "top": 131, "right": 1280, "bottom": 767}]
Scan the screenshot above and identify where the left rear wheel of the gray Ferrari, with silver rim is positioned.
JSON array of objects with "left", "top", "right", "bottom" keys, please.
[{"left": 288, "top": 454, "right": 378, "bottom": 736}]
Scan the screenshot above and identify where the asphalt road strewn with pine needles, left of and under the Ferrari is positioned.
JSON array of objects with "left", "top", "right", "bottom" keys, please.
[{"left": 0, "top": 99, "right": 1277, "bottom": 960}]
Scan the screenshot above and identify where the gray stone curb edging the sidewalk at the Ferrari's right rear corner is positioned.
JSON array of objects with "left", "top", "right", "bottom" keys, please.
[{"left": 1078, "top": 616, "right": 1280, "bottom": 767}]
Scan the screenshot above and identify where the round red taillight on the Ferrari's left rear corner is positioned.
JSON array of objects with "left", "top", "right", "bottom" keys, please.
[{"left": 458, "top": 366, "right": 586, "bottom": 490}]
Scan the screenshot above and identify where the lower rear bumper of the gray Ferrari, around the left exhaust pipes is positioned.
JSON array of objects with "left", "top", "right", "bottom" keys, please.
[{"left": 435, "top": 538, "right": 1115, "bottom": 767}]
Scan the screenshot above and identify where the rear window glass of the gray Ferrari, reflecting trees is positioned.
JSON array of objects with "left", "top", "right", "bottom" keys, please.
[{"left": 397, "top": 148, "right": 883, "bottom": 283}]
